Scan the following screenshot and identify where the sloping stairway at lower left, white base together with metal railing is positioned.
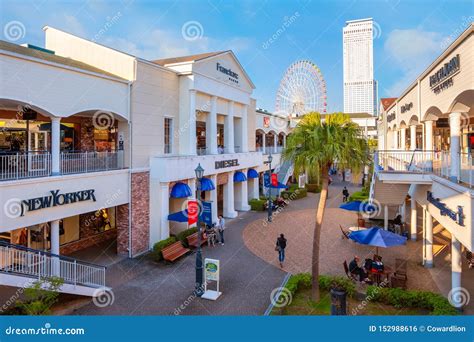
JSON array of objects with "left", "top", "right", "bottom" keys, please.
[{"left": 0, "top": 241, "right": 107, "bottom": 296}]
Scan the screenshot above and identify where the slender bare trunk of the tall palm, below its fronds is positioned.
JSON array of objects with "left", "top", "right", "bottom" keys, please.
[{"left": 311, "top": 168, "right": 329, "bottom": 302}]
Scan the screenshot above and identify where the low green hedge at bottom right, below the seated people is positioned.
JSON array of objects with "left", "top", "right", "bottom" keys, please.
[{"left": 367, "top": 286, "right": 458, "bottom": 315}]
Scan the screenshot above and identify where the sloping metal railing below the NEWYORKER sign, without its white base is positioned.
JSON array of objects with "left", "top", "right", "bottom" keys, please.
[{"left": 0, "top": 241, "right": 106, "bottom": 288}]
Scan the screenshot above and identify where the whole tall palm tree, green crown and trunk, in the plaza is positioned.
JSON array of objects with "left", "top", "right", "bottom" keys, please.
[{"left": 282, "top": 112, "right": 368, "bottom": 301}]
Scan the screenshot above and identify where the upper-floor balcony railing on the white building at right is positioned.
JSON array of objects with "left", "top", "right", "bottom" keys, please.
[{"left": 375, "top": 150, "right": 474, "bottom": 188}]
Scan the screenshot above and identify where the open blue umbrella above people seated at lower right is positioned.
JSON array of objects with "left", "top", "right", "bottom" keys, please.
[{"left": 349, "top": 227, "right": 407, "bottom": 254}]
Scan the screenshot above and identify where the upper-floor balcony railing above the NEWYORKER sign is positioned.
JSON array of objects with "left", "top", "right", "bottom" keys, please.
[{"left": 0, "top": 151, "right": 124, "bottom": 181}]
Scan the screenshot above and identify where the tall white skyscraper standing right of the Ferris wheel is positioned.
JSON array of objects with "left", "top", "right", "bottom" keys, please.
[{"left": 342, "top": 18, "right": 377, "bottom": 115}]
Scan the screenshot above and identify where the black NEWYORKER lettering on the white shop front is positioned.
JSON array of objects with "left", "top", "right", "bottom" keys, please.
[{"left": 20, "top": 189, "right": 96, "bottom": 216}]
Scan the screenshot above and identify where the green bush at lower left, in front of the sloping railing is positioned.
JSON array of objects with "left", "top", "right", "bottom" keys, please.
[{"left": 17, "top": 277, "right": 64, "bottom": 315}]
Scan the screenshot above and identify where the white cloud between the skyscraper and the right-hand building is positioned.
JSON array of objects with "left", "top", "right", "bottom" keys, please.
[{"left": 384, "top": 29, "right": 446, "bottom": 96}]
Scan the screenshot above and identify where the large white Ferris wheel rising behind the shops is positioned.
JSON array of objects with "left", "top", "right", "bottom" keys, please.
[{"left": 275, "top": 60, "right": 327, "bottom": 118}]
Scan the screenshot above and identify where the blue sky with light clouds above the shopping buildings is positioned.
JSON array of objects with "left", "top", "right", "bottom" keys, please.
[{"left": 0, "top": 0, "right": 474, "bottom": 112}]
